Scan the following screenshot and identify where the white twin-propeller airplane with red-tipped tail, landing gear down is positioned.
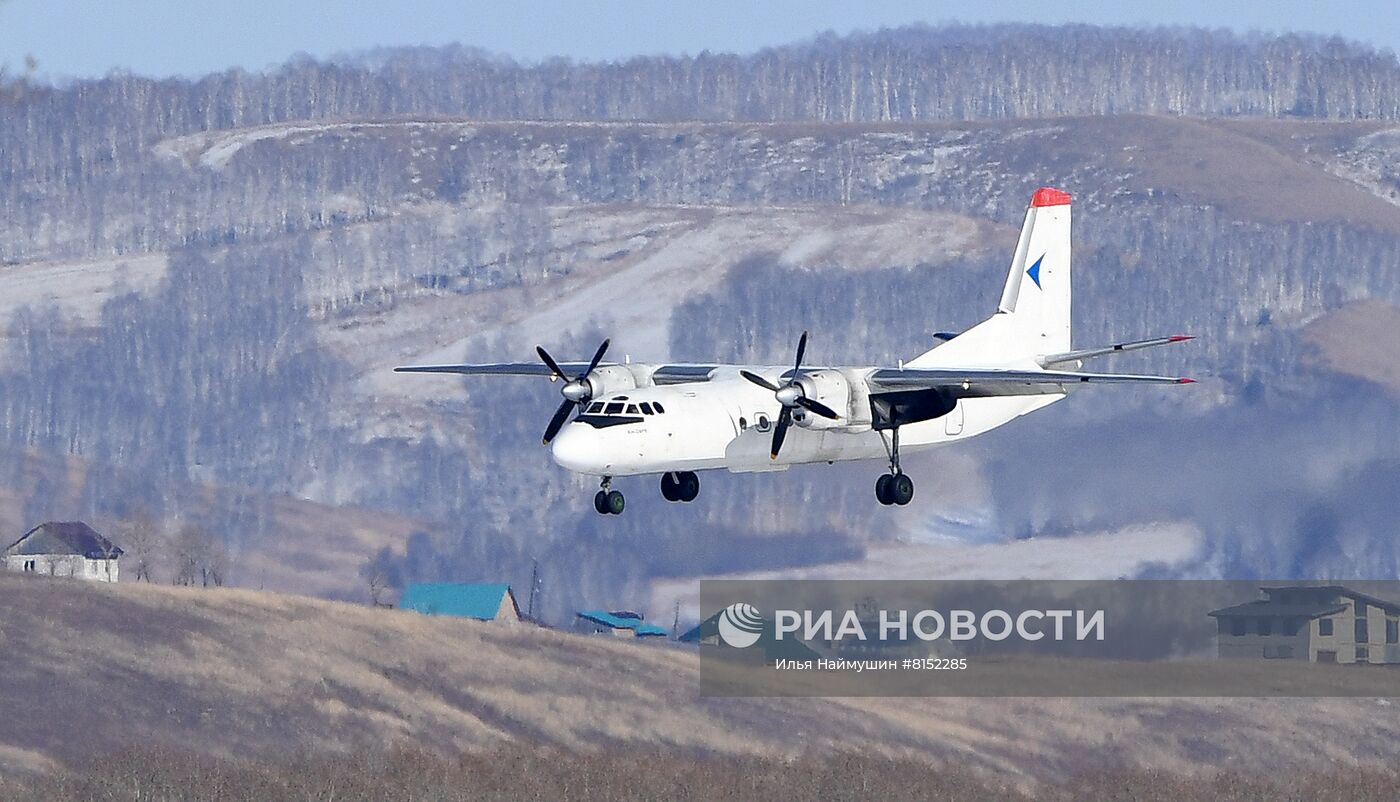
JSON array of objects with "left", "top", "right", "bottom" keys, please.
[{"left": 395, "top": 188, "right": 1193, "bottom": 515}]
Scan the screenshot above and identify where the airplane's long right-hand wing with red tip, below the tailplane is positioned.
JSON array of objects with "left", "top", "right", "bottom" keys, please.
[{"left": 868, "top": 368, "right": 1196, "bottom": 398}]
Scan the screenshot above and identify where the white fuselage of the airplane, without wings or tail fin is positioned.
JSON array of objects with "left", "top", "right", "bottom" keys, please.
[{"left": 552, "top": 370, "right": 1065, "bottom": 476}]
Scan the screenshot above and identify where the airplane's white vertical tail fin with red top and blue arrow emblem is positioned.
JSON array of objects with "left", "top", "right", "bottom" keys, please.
[{"left": 907, "top": 188, "right": 1070, "bottom": 367}]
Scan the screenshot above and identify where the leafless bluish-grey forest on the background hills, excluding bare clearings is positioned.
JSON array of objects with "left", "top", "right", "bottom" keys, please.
[{"left": 0, "top": 25, "right": 1400, "bottom": 617}]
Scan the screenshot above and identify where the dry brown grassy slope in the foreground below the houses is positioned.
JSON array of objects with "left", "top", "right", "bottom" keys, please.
[{"left": 0, "top": 575, "right": 1400, "bottom": 781}]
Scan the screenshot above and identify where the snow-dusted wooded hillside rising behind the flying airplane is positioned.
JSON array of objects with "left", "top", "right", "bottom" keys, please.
[{"left": 0, "top": 25, "right": 1400, "bottom": 621}]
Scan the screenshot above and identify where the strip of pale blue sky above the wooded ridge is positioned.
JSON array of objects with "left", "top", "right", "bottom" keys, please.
[{"left": 0, "top": 0, "right": 1400, "bottom": 78}]
